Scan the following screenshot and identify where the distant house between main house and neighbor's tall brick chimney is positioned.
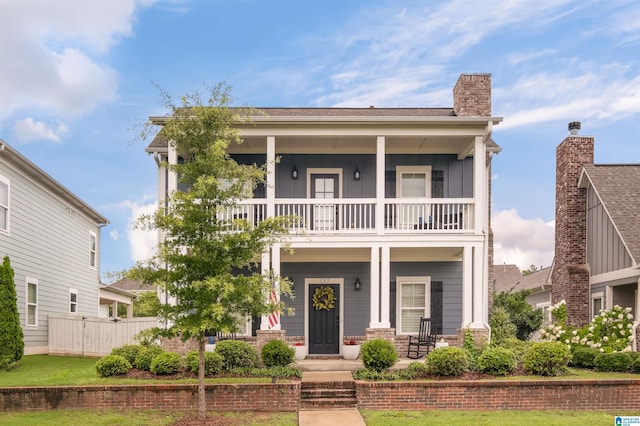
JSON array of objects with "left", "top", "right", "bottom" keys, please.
[{"left": 493, "top": 265, "right": 553, "bottom": 324}]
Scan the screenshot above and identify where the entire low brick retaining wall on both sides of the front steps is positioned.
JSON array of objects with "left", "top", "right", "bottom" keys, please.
[{"left": 0, "top": 379, "right": 640, "bottom": 412}]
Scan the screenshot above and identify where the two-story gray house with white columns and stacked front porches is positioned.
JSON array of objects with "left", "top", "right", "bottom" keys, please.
[{"left": 147, "top": 74, "right": 502, "bottom": 355}]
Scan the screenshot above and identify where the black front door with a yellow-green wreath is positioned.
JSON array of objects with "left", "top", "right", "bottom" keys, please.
[{"left": 308, "top": 284, "right": 340, "bottom": 354}]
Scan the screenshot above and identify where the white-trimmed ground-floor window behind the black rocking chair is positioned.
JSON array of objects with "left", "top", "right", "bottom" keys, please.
[{"left": 397, "top": 277, "right": 431, "bottom": 334}]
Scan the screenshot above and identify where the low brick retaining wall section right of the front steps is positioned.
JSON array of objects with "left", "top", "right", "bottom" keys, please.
[{"left": 356, "top": 379, "right": 640, "bottom": 411}]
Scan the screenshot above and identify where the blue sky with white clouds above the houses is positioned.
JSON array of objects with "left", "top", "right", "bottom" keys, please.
[{"left": 0, "top": 0, "right": 640, "bottom": 280}]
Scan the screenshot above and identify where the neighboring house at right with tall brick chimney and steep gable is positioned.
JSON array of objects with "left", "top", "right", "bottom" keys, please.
[{"left": 553, "top": 122, "right": 640, "bottom": 341}]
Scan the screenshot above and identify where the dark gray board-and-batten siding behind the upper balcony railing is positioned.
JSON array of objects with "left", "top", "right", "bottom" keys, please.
[{"left": 231, "top": 154, "right": 473, "bottom": 198}]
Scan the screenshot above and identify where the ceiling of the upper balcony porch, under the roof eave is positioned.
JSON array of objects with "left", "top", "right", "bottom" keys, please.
[{"left": 229, "top": 134, "right": 476, "bottom": 155}]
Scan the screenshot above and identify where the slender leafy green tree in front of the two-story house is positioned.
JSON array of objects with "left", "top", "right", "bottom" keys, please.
[{"left": 128, "top": 85, "right": 291, "bottom": 418}]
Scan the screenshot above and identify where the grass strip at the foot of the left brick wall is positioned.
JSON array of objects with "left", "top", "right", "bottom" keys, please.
[{"left": 0, "top": 410, "right": 298, "bottom": 426}]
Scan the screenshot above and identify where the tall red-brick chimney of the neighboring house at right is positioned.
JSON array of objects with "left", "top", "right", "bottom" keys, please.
[{"left": 551, "top": 121, "right": 594, "bottom": 326}]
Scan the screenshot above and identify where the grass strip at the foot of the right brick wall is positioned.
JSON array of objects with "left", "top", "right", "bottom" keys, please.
[{"left": 361, "top": 410, "right": 638, "bottom": 426}]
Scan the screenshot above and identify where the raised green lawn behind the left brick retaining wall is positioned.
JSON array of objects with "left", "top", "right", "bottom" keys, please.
[{"left": 0, "top": 355, "right": 271, "bottom": 387}]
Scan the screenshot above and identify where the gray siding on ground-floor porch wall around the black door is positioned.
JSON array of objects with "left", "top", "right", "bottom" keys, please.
[{"left": 280, "top": 262, "right": 462, "bottom": 336}]
